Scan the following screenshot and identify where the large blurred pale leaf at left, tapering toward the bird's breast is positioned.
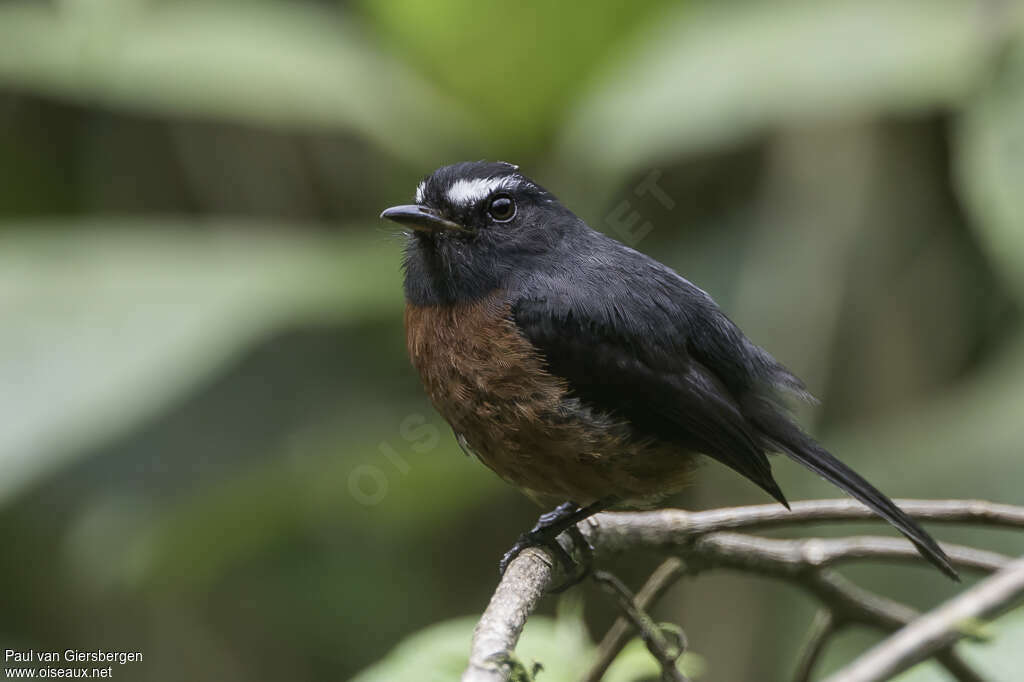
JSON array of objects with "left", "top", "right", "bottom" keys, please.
[{"left": 0, "top": 221, "right": 401, "bottom": 503}]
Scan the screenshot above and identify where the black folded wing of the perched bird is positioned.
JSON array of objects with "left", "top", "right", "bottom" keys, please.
[{"left": 513, "top": 273, "right": 785, "bottom": 504}]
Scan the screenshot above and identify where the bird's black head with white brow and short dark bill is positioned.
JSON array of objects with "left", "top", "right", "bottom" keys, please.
[{"left": 381, "top": 161, "right": 586, "bottom": 303}]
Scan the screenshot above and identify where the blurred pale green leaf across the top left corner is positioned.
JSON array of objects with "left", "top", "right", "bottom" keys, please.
[{"left": 0, "top": 0, "right": 474, "bottom": 164}]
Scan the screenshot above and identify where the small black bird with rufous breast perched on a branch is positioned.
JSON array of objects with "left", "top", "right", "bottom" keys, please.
[{"left": 381, "top": 161, "right": 958, "bottom": 580}]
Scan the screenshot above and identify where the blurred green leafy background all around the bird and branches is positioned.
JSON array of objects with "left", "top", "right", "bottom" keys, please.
[{"left": 0, "top": 0, "right": 1024, "bottom": 682}]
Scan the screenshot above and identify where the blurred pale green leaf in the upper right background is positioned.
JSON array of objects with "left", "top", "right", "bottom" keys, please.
[{"left": 561, "top": 0, "right": 1021, "bottom": 178}]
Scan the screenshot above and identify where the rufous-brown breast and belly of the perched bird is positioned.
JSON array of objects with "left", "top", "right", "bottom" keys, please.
[{"left": 406, "top": 298, "right": 695, "bottom": 505}]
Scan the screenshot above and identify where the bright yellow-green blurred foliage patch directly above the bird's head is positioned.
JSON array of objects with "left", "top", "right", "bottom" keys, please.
[{"left": 359, "top": 0, "right": 670, "bottom": 156}]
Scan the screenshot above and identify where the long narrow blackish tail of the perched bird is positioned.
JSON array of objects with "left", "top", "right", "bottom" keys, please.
[{"left": 751, "top": 399, "right": 959, "bottom": 582}]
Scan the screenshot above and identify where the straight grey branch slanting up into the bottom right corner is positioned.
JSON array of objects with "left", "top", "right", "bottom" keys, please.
[{"left": 827, "top": 558, "right": 1024, "bottom": 682}]
